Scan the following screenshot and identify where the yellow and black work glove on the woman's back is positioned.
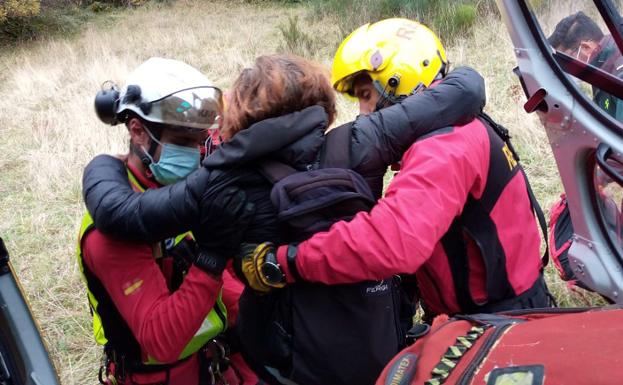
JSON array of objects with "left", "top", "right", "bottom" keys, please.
[{"left": 234, "top": 242, "right": 286, "bottom": 293}]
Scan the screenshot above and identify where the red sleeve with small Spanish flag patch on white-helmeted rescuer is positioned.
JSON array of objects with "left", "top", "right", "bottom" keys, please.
[{"left": 84, "top": 230, "right": 221, "bottom": 362}]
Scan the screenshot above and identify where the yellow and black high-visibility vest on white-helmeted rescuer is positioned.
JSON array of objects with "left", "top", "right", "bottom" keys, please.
[{"left": 77, "top": 166, "right": 232, "bottom": 385}]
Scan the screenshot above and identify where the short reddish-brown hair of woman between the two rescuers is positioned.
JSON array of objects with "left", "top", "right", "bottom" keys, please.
[{"left": 221, "top": 55, "right": 336, "bottom": 138}]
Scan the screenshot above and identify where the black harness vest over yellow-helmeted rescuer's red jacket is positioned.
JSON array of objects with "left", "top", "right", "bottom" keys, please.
[{"left": 427, "top": 113, "right": 551, "bottom": 314}]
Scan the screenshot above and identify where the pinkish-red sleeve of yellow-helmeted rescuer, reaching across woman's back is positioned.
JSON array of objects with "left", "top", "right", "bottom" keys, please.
[{"left": 292, "top": 122, "right": 489, "bottom": 284}]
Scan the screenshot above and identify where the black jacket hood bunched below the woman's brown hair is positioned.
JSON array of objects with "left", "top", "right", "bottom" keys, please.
[{"left": 203, "top": 106, "right": 328, "bottom": 170}]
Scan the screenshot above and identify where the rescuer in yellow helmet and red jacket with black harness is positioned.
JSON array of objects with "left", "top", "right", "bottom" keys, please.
[{"left": 241, "top": 19, "right": 550, "bottom": 317}]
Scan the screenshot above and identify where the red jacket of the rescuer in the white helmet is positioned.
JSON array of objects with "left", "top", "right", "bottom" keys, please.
[{"left": 83, "top": 165, "right": 257, "bottom": 385}]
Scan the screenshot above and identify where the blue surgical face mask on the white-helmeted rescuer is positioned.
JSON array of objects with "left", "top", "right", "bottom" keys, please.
[{"left": 143, "top": 128, "right": 201, "bottom": 185}]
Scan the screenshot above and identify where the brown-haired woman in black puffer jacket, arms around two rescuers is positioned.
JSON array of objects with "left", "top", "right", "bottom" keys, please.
[{"left": 83, "top": 55, "right": 485, "bottom": 385}]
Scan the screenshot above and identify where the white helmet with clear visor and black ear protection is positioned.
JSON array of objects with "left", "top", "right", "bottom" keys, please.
[{"left": 95, "top": 57, "right": 223, "bottom": 130}]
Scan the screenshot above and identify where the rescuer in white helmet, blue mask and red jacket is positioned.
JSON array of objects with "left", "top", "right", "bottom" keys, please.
[{"left": 77, "top": 58, "right": 256, "bottom": 385}]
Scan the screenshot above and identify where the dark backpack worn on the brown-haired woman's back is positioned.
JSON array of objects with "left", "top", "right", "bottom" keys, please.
[{"left": 238, "top": 123, "right": 406, "bottom": 385}]
